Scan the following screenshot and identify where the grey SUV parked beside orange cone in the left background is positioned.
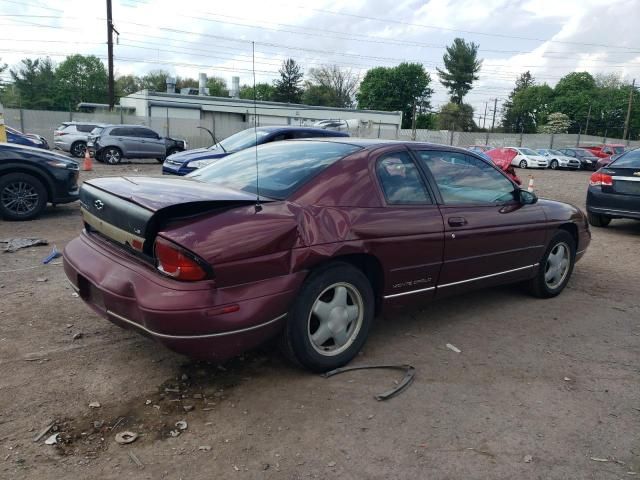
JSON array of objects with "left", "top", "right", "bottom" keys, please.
[{"left": 87, "top": 125, "right": 187, "bottom": 165}]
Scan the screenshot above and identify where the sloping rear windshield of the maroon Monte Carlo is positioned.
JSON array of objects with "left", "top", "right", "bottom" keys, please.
[{"left": 188, "top": 141, "right": 360, "bottom": 200}]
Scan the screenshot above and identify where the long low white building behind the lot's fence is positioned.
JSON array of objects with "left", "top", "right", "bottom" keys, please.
[{"left": 120, "top": 90, "right": 402, "bottom": 138}]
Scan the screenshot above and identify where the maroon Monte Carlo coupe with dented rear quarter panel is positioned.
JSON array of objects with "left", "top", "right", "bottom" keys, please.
[{"left": 64, "top": 139, "right": 590, "bottom": 371}]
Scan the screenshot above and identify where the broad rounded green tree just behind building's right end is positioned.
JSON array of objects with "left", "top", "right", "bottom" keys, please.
[{"left": 356, "top": 63, "right": 433, "bottom": 128}]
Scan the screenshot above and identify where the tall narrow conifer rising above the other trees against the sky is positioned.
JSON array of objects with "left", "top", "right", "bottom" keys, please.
[{"left": 436, "top": 38, "right": 482, "bottom": 105}]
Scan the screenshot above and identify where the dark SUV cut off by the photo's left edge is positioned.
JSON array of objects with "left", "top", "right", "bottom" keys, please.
[{"left": 0, "top": 143, "right": 79, "bottom": 220}]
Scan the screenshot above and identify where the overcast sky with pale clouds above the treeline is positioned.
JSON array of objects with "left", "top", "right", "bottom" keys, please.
[{"left": 0, "top": 0, "right": 640, "bottom": 121}]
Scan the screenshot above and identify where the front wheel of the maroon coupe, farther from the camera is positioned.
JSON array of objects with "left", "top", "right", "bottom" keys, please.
[{"left": 529, "top": 230, "right": 576, "bottom": 298}]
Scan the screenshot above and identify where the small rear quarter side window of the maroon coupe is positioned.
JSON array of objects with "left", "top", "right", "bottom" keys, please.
[{"left": 376, "top": 152, "right": 433, "bottom": 205}]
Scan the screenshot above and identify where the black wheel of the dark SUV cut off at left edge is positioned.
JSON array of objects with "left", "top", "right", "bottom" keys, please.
[{"left": 0, "top": 173, "right": 47, "bottom": 220}]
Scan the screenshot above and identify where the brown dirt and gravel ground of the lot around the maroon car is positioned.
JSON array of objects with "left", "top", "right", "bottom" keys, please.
[{"left": 0, "top": 162, "right": 640, "bottom": 480}]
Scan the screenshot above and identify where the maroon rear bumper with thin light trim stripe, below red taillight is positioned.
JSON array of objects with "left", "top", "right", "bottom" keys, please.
[{"left": 64, "top": 233, "right": 304, "bottom": 361}]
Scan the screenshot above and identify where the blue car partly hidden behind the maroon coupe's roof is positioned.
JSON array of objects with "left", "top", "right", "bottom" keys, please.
[{"left": 162, "top": 127, "right": 349, "bottom": 175}]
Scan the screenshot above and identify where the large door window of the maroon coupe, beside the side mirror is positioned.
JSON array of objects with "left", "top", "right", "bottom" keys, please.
[{"left": 418, "top": 151, "right": 515, "bottom": 205}]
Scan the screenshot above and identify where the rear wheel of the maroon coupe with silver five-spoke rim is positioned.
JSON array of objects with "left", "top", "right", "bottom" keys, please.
[{"left": 281, "top": 262, "right": 375, "bottom": 372}]
